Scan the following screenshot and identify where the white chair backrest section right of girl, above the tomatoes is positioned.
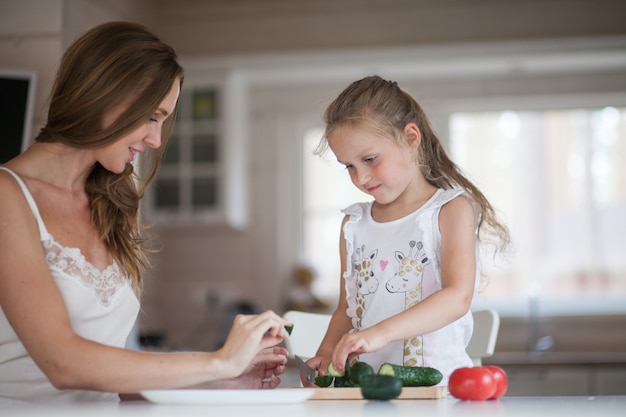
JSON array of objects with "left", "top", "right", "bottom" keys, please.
[{"left": 466, "top": 309, "right": 500, "bottom": 366}]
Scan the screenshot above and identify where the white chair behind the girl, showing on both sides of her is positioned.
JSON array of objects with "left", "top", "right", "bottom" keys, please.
[{"left": 283, "top": 309, "right": 500, "bottom": 365}]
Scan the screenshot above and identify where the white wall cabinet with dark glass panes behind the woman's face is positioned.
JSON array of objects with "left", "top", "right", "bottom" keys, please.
[{"left": 146, "top": 79, "right": 248, "bottom": 229}]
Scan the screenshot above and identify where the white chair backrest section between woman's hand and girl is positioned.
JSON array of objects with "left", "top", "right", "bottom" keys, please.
[{"left": 283, "top": 310, "right": 330, "bottom": 359}]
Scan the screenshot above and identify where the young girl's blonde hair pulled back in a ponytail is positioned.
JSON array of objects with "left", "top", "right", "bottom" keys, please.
[{"left": 315, "top": 76, "right": 509, "bottom": 249}]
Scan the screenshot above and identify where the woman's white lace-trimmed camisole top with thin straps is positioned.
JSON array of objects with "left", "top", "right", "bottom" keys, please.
[{"left": 0, "top": 167, "right": 139, "bottom": 404}]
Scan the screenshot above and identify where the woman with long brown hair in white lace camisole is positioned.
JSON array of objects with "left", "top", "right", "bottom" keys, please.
[{"left": 0, "top": 22, "right": 289, "bottom": 404}]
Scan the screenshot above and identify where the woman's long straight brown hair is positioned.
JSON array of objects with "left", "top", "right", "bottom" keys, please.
[{"left": 35, "top": 22, "right": 183, "bottom": 294}]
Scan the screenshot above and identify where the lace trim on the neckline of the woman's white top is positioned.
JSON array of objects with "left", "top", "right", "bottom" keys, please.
[{"left": 42, "top": 236, "right": 128, "bottom": 307}]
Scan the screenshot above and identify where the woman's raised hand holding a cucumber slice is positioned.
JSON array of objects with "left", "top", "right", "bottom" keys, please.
[{"left": 216, "top": 310, "right": 290, "bottom": 377}]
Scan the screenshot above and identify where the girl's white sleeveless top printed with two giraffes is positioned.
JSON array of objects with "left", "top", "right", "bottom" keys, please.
[{"left": 343, "top": 189, "right": 480, "bottom": 385}]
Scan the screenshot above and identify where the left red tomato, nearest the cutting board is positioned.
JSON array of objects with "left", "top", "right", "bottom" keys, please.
[{"left": 448, "top": 366, "right": 496, "bottom": 400}]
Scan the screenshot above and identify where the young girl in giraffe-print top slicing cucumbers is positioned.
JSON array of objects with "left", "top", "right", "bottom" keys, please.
[{"left": 308, "top": 76, "right": 508, "bottom": 385}]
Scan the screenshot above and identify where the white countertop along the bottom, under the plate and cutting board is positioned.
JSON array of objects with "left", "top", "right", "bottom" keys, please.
[{"left": 0, "top": 396, "right": 626, "bottom": 417}]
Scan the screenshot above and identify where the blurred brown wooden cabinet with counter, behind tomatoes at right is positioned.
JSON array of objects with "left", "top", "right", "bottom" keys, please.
[{"left": 483, "top": 314, "right": 626, "bottom": 396}]
